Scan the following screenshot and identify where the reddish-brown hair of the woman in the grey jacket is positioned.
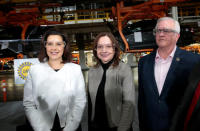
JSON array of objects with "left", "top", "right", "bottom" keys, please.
[{"left": 93, "top": 32, "right": 120, "bottom": 67}]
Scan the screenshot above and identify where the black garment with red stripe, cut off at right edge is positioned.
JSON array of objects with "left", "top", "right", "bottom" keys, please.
[{"left": 170, "top": 62, "right": 200, "bottom": 131}]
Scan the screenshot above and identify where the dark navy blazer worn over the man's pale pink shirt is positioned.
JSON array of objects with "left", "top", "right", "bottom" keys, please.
[{"left": 138, "top": 47, "right": 200, "bottom": 131}]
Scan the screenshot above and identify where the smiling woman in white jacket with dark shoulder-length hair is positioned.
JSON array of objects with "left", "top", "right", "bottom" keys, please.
[{"left": 23, "top": 30, "right": 86, "bottom": 131}]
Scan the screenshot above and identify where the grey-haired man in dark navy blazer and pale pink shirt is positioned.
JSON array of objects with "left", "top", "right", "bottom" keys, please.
[{"left": 138, "top": 17, "right": 200, "bottom": 131}]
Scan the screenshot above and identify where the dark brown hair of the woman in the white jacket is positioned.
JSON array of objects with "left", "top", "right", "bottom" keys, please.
[{"left": 38, "top": 29, "right": 72, "bottom": 63}]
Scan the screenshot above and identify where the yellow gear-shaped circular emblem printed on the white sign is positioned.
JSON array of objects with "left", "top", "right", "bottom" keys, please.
[{"left": 17, "top": 62, "right": 32, "bottom": 80}]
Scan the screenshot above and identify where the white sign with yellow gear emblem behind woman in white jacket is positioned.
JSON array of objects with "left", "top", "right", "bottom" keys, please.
[{"left": 14, "top": 58, "right": 39, "bottom": 84}]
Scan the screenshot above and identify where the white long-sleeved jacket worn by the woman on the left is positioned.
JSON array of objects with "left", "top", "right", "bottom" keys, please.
[{"left": 23, "top": 63, "right": 86, "bottom": 131}]
